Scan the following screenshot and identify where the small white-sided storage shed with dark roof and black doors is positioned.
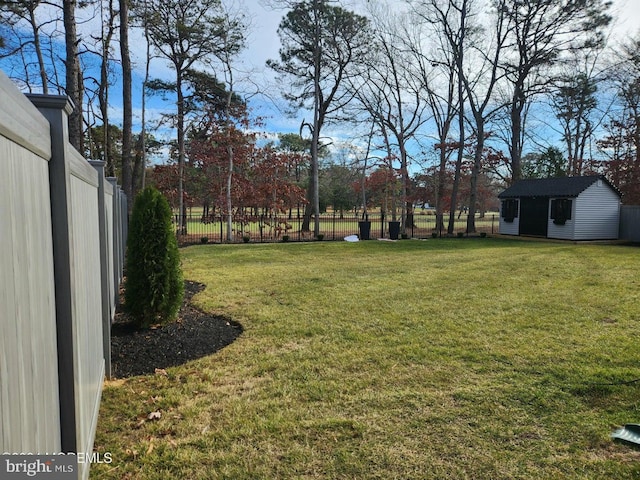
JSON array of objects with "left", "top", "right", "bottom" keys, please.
[{"left": 498, "top": 175, "right": 621, "bottom": 240}]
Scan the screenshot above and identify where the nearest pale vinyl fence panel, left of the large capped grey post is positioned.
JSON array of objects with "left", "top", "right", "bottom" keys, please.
[{"left": 0, "top": 76, "right": 61, "bottom": 452}]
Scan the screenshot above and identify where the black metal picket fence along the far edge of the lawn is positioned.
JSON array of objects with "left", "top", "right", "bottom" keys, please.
[{"left": 174, "top": 212, "right": 498, "bottom": 245}]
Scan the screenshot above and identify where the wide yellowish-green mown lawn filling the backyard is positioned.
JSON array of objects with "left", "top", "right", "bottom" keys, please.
[{"left": 92, "top": 239, "right": 640, "bottom": 480}]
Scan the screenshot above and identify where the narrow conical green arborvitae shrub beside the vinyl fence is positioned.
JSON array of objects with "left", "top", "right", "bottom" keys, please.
[{"left": 124, "top": 187, "right": 184, "bottom": 327}]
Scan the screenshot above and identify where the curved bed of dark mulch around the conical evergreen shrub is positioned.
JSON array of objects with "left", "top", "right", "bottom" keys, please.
[{"left": 111, "top": 281, "right": 242, "bottom": 378}]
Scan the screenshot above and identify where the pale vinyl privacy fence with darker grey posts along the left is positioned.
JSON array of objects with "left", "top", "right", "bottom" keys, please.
[{"left": 0, "top": 72, "right": 127, "bottom": 478}]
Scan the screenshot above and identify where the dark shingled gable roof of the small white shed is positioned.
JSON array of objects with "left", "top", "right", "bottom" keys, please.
[{"left": 498, "top": 175, "right": 620, "bottom": 198}]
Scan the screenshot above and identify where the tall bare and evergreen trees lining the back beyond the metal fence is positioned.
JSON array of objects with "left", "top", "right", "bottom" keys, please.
[{"left": 0, "top": 0, "right": 640, "bottom": 236}]
